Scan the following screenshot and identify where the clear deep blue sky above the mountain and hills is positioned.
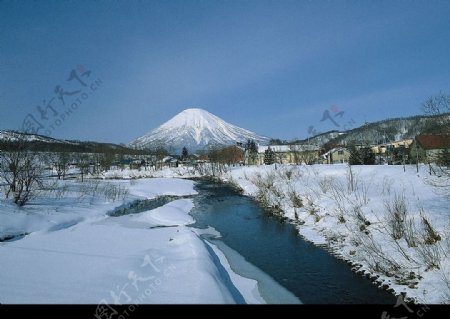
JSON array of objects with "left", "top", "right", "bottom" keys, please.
[{"left": 0, "top": 0, "right": 450, "bottom": 143}]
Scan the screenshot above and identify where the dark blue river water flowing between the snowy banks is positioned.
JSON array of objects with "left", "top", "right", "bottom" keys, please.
[{"left": 191, "top": 181, "right": 396, "bottom": 305}]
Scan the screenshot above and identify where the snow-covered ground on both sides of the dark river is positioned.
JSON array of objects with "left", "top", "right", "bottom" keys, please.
[{"left": 0, "top": 165, "right": 450, "bottom": 305}]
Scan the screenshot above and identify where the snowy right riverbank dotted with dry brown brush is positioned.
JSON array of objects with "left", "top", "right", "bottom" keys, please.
[{"left": 223, "top": 165, "right": 450, "bottom": 303}]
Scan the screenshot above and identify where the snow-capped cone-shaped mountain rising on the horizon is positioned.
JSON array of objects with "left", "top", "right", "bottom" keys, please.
[{"left": 129, "top": 108, "right": 269, "bottom": 152}]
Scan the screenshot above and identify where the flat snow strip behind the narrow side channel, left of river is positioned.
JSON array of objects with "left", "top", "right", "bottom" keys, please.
[{"left": 0, "top": 178, "right": 197, "bottom": 239}]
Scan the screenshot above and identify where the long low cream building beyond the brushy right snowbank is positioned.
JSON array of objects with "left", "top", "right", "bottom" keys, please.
[{"left": 244, "top": 144, "right": 320, "bottom": 165}]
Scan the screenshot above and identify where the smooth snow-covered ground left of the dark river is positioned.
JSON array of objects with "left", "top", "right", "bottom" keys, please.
[{"left": 0, "top": 178, "right": 264, "bottom": 304}]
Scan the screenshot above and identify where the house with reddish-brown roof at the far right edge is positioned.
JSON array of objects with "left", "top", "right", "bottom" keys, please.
[{"left": 411, "top": 134, "right": 450, "bottom": 163}]
